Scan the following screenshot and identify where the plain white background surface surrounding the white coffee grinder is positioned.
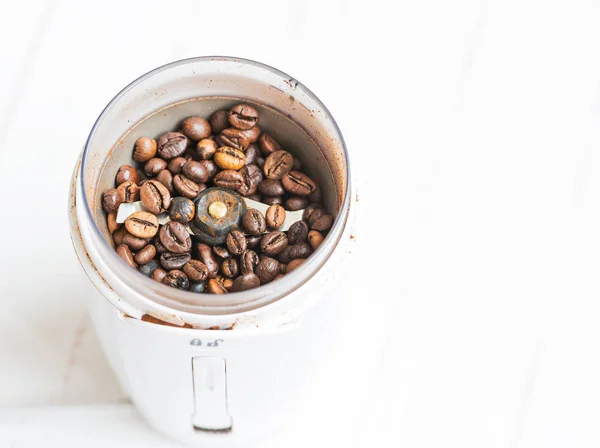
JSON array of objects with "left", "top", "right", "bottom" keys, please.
[{"left": 0, "top": 0, "right": 600, "bottom": 448}]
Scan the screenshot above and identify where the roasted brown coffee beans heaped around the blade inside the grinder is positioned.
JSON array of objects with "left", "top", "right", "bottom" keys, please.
[{"left": 102, "top": 104, "right": 334, "bottom": 294}]
